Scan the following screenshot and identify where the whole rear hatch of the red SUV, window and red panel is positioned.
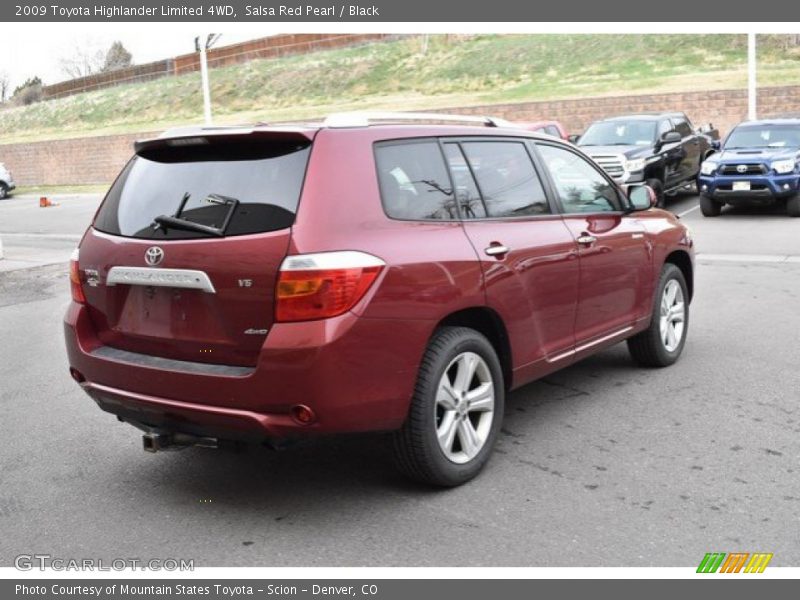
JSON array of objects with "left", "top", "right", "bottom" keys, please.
[{"left": 79, "top": 130, "right": 314, "bottom": 366}]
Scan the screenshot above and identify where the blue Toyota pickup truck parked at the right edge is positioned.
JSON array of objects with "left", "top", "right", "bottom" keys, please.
[{"left": 698, "top": 119, "right": 800, "bottom": 217}]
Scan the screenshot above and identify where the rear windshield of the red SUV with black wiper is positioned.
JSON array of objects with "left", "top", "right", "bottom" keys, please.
[{"left": 94, "top": 140, "right": 311, "bottom": 239}]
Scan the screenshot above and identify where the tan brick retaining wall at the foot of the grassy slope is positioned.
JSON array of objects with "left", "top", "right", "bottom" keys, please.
[{"left": 0, "top": 86, "right": 800, "bottom": 185}]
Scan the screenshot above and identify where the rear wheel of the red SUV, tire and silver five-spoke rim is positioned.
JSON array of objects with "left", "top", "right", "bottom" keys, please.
[{"left": 393, "top": 327, "right": 505, "bottom": 487}]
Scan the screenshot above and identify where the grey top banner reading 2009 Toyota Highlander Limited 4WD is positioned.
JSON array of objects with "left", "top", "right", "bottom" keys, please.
[{"left": 0, "top": 0, "right": 800, "bottom": 21}]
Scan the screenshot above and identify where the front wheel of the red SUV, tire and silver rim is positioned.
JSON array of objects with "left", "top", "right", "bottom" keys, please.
[{"left": 628, "top": 263, "right": 689, "bottom": 367}]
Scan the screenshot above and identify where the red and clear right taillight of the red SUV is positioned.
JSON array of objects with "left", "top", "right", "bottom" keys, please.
[{"left": 275, "top": 250, "right": 386, "bottom": 322}]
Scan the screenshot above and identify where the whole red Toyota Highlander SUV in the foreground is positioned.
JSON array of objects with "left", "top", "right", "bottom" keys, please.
[{"left": 65, "top": 114, "right": 694, "bottom": 486}]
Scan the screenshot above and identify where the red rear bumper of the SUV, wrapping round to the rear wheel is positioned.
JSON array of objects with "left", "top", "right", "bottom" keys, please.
[{"left": 64, "top": 302, "right": 434, "bottom": 441}]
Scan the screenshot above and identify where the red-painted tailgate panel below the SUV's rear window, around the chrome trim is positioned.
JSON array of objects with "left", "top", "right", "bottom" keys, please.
[{"left": 81, "top": 229, "right": 289, "bottom": 365}]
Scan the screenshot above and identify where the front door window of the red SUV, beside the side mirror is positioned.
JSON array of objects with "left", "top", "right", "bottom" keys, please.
[{"left": 538, "top": 144, "right": 620, "bottom": 213}]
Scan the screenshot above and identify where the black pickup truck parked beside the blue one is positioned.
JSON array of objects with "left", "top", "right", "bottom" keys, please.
[{"left": 577, "top": 112, "right": 719, "bottom": 207}]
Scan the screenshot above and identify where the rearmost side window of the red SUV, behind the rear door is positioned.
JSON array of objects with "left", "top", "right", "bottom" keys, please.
[{"left": 375, "top": 140, "right": 458, "bottom": 221}]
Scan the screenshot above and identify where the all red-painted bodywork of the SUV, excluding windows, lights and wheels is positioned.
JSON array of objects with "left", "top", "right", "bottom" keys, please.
[{"left": 65, "top": 126, "right": 693, "bottom": 439}]
